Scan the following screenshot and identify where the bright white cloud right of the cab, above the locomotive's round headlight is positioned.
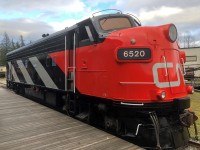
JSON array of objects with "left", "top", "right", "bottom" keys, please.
[{"left": 139, "top": 6, "right": 200, "bottom": 39}]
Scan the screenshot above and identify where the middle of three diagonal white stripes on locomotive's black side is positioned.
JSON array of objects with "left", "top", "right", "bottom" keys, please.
[{"left": 17, "top": 60, "right": 34, "bottom": 84}]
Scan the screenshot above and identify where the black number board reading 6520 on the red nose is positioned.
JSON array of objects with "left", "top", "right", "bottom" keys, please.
[{"left": 117, "top": 48, "right": 151, "bottom": 60}]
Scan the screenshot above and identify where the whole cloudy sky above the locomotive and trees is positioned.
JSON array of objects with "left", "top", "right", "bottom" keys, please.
[{"left": 0, "top": 0, "right": 200, "bottom": 42}]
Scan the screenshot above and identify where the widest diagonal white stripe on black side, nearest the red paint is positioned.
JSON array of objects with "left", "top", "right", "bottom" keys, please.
[{"left": 29, "top": 57, "right": 58, "bottom": 89}]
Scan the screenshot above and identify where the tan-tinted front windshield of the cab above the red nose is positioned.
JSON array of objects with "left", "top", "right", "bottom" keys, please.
[{"left": 99, "top": 17, "right": 132, "bottom": 31}]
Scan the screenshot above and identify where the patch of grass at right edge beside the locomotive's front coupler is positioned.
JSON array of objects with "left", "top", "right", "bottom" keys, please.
[{"left": 189, "top": 92, "right": 200, "bottom": 137}]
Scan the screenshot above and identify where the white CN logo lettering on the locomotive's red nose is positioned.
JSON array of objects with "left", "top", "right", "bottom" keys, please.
[{"left": 152, "top": 63, "right": 181, "bottom": 88}]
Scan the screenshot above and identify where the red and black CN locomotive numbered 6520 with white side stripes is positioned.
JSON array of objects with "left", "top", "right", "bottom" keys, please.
[{"left": 7, "top": 10, "right": 197, "bottom": 149}]
